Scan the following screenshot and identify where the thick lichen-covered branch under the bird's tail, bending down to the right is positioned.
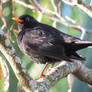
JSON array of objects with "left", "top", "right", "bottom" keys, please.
[{"left": 41, "top": 61, "right": 92, "bottom": 88}]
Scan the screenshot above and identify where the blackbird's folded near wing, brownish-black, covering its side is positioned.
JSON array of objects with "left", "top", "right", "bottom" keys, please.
[{"left": 23, "top": 28, "right": 65, "bottom": 60}]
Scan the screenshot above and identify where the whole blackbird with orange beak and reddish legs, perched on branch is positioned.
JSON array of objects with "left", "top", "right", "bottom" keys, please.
[{"left": 13, "top": 14, "right": 92, "bottom": 77}]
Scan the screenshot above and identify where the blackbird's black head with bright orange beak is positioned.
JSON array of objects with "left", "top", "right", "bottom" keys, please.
[{"left": 12, "top": 15, "right": 38, "bottom": 30}]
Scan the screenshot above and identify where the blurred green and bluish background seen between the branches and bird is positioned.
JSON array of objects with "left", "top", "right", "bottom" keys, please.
[{"left": 0, "top": 0, "right": 92, "bottom": 92}]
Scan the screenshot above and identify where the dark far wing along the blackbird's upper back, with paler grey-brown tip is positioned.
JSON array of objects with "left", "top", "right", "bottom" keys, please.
[{"left": 41, "top": 24, "right": 80, "bottom": 44}]
